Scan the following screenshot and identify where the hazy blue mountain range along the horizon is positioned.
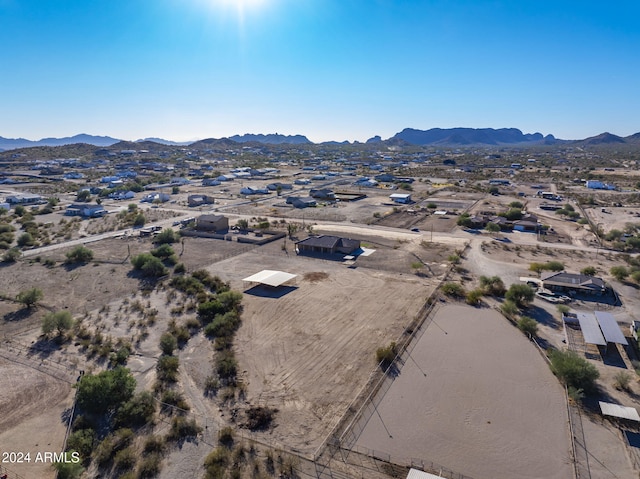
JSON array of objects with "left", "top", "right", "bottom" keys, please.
[{"left": 0, "top": 128, "right": 640, "bottom": 150}]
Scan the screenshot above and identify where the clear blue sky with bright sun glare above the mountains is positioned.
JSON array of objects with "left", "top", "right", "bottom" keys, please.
[{"left": 0, "top": 0, "right": 640, "bottom": 142}]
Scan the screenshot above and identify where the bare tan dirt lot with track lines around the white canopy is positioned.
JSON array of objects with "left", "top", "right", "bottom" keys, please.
[{"left": 208, "top": 246, "right": 435, "bottom": 454}]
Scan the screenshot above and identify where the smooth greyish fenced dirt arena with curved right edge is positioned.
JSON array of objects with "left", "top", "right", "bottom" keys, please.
[{"left": 357, "top": 305, "right": 573, "bottom": 479}]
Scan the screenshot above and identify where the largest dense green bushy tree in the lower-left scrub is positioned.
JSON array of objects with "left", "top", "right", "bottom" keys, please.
[{"left": 76, "top": 366, "right": 136, "bottom": 413}]
